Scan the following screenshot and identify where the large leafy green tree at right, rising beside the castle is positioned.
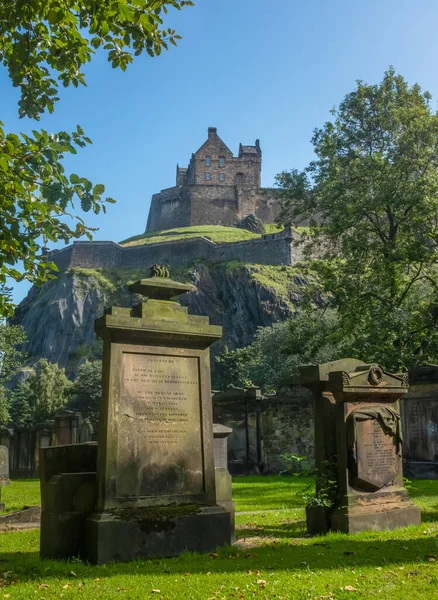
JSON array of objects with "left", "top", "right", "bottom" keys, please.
[{"left": 277, "top": 68, "right": 438, "bottom": 368}]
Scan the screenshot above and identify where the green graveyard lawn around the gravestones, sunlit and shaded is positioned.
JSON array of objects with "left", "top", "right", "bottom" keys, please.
[{"left": 0, "top": 477, "right": 438, "bottom": 600}]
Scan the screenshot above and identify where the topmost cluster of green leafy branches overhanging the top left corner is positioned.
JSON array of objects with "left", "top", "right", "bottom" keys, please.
[{"left": 0, "top": 0, "right": 193, "bottom": 119}]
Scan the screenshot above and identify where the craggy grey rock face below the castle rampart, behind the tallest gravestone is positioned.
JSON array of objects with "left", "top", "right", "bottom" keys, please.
[{"left": 13, "top": 263, "right": 305, "bottom": 376}]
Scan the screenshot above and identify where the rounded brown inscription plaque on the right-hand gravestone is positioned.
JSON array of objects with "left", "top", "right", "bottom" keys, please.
[{"left": 356, "top": 419, "right": 400, "bottom": 491}]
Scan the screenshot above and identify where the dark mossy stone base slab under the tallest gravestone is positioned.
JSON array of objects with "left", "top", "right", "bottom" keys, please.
[{"left": 86, "top": 506, "right": 232, "bottom": 564}]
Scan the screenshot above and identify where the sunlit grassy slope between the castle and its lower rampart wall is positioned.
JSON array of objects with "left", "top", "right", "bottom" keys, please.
[{"left": 120, "top": 224, "right": 282, "bottom": 246}]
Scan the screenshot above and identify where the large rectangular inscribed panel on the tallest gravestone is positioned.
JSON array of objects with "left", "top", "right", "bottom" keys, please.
[{"left": 116, "top": 352, "right": 204, "bottom": 497}]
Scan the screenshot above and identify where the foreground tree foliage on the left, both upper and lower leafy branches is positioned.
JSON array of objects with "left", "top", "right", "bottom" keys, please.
[{"left": 0, "top": 0, "right": 192, "bottom": 316}]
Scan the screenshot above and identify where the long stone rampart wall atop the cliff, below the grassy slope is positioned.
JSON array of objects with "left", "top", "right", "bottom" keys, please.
[{"left": 49, "top": 228, "right": 301, "bottom": 271}]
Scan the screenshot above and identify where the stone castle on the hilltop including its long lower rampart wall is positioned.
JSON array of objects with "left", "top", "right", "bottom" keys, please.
[{"left": 50, "top": 127, "right": 301, "bottom": 271}]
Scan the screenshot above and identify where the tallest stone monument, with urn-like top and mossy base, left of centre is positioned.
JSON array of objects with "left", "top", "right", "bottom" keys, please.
[{"left": 86, "top": 266, "right": 232, "bottom": 563}]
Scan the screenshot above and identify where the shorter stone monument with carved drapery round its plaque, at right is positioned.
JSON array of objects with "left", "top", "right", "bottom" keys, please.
[{"left": 300, "top": 359, "right": 421, "bottom": 534}]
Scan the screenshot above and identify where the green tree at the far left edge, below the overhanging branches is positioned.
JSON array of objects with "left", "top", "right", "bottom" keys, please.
[{"left": 0, "top": 318, "right": 26, "bottom": 427}]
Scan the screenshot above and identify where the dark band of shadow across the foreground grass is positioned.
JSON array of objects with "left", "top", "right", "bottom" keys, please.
[{"left": 0, "top": 524, "right": 438, "bottom": 581}]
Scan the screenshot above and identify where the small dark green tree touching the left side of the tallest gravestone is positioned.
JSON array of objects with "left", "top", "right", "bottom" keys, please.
[{"left": 68, "top": 360, "right": 102, "bottom": 429}]
